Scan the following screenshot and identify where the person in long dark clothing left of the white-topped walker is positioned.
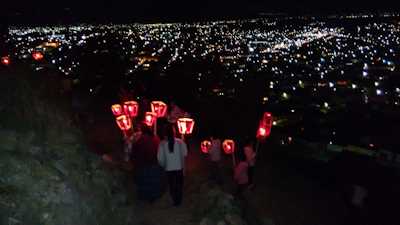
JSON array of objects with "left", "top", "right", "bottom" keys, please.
[{"left": 132, "top": 124, "right": 162, "bottom": 202}]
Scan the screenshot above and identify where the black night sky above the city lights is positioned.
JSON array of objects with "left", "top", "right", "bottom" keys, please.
[{"left": 1, "top": 0, "right": 400, "bottom": 23}]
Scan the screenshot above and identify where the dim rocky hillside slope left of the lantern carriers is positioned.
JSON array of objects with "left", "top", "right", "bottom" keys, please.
[{"left": 0, "top": 68, "right": 135, "bottom": 225}]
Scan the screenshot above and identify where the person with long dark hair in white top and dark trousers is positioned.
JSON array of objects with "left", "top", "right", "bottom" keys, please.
[{"left": 157, "top": 124, "right": 187, "bottom": 206}]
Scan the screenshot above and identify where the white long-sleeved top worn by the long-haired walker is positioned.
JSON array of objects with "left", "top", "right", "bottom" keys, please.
[{"left": 157, "top": 138, "right": 187, "bottom": 171}]
